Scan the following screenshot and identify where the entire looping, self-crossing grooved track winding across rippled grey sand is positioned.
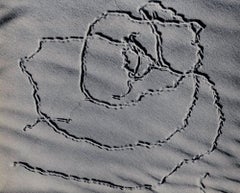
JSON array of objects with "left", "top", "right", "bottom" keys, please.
[{"left": 14, "top": 1, "right": 225, "bottom": 192}]
